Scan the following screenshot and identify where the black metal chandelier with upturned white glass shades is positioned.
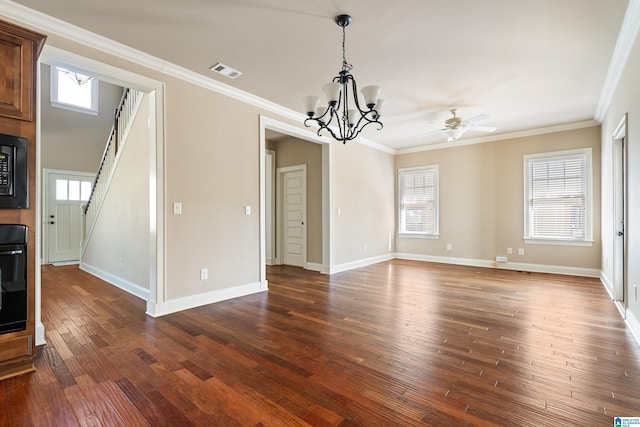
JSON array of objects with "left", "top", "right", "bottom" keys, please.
[{"left": 304, "top": 15, "right": 384, "bottom": 144}]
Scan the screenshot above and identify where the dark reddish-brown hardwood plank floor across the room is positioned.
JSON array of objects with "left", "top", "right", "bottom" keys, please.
[{"left": 0, "top": 260, "right": 640, "bottom": 427}]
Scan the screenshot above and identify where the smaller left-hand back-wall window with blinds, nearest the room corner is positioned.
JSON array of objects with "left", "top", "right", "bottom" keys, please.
[{"left": 398, "top": 165, "right": 438, "bottom": 237}]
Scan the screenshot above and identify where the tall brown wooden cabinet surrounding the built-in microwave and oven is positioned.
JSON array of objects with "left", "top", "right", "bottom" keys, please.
[{"left": 0, "top": 21, "right": 46, "bottom": 379}]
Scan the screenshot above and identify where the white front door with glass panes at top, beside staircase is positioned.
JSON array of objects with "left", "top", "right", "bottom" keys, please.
[{"left": 44, "top": 171, "right": 93, "bottom": 263}]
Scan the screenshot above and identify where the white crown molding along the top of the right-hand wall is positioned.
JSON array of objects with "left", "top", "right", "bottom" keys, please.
[{"left": 594, "top": 0, "right": 640, "bottom": 123}]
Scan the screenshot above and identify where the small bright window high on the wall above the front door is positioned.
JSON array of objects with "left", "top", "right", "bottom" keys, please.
[{"left": 51, "top": 66, "right": 98, "bottom": 115}]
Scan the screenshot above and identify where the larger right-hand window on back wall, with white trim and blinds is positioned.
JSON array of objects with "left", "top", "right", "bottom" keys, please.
[{"left": 524, "top": 148, "right": 592, "bottom": 244}]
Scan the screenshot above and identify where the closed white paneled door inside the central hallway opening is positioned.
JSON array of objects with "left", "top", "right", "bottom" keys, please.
[{"left": 280, "top": 165, "right": 307, "bottom": 267}]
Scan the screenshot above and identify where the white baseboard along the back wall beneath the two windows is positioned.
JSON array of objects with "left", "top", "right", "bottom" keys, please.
[{"left": 396, "top": 253, "right": 600, "bottom": 277}]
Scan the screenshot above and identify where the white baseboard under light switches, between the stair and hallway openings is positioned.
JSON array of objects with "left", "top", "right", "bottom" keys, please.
[{"left": 147, "top": 282, "right": 269, "bottom": 317}]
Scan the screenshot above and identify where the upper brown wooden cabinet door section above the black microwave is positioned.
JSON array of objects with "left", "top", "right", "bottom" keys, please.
[{"left": 0, "top": 21, "right": 45, "bottom": 121}]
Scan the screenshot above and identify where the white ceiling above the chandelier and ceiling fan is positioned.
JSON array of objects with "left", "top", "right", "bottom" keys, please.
[{"left": 6, "top": 0, "right": 628, "bottom": 150}]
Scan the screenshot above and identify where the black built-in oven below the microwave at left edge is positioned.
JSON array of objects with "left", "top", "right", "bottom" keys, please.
[{"left": 0, "top": 224, "right": 28, "bottom": 334}]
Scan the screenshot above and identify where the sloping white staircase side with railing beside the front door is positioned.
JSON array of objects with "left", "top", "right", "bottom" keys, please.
[{"left": 82, "top": 88, "right": 144, "bottom": 253}]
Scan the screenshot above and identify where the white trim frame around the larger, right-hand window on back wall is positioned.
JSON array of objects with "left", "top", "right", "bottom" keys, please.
[{"left": 523, "top": 147, "right": 593, "bottom": 246}]
